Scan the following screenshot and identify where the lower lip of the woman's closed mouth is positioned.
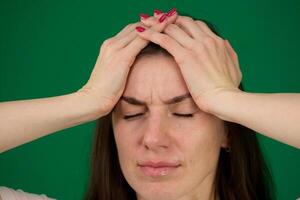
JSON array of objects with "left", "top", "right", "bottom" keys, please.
[{"left": 139, "top": 166, "right": 179, "bottom": 177}]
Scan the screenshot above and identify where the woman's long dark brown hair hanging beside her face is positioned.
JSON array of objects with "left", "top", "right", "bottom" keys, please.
[{"left": 85, "top": 17, "right": 275, "bottom": 200}]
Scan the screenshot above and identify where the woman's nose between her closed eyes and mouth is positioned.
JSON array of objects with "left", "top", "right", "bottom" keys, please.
[{"left": 142, "top": 112, "right": 170, "bottom": 151}]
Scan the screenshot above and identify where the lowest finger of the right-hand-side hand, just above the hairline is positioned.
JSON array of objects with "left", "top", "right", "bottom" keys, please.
[{"left": 137, "top": 25, "right": 185, "bottom": 63}]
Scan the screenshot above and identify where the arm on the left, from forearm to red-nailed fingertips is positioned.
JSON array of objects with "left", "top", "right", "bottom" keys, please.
[{"left": 0, "top": 13, "right": 177, "bottom": 152}]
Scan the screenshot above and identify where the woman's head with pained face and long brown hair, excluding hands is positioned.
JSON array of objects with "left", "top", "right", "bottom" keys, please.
[{"left": 86, "top": 11, "right": 273, "bottom": 200}]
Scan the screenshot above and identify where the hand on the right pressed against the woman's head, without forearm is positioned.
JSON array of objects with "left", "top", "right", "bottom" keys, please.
[{"left": 138, "top": 13, "right": 242, "bottom": 112}]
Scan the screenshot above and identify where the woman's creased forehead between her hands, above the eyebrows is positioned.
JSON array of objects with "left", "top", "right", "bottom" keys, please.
[{"left": 123, "top": 54, "right": 189, "bottom": 104}]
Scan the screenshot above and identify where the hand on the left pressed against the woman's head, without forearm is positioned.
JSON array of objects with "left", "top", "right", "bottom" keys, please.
[{"left": 77, "top": 9, "right": 177, "bottom": 116}]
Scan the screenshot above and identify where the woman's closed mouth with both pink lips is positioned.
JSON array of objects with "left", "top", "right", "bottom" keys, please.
[{"left": 138, "top": 161, "right": 181, "bottom": 178}]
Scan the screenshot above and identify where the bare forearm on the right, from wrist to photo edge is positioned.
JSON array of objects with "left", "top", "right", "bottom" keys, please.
[{"left": 207, "top": 91, "right": 300, "bottom": 148}]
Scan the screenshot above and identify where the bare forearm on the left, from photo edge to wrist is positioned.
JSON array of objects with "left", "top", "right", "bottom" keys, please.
[{"left": 0, "top": 92, "right": 105, "bottom": 152}]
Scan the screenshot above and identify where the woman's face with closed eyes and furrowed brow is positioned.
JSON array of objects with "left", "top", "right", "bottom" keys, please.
[{"left": 112, "top": 54, "right": 227, "bottom": 200}]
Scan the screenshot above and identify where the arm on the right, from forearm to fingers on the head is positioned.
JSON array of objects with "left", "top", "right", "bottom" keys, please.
[{"left": 139, "top": 16, "right": 300, "bottom": 148}]
